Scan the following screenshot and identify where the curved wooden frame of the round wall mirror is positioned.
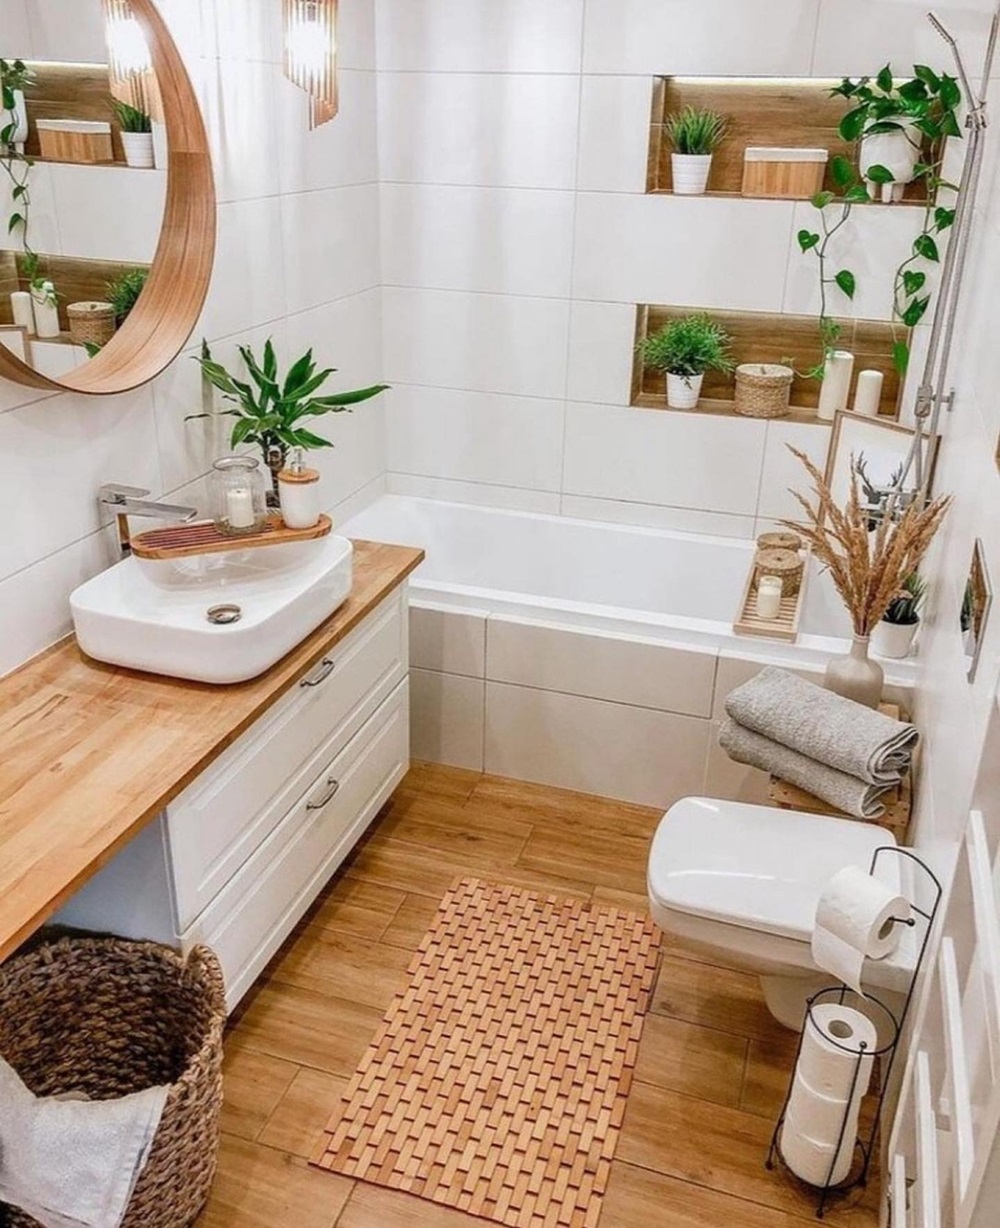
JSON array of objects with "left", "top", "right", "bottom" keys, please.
[{"left": 0, "top": 0, "right": 215, "bottom": 397}]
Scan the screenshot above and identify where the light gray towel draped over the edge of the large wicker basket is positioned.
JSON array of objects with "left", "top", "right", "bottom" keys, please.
[{"left": 0, "top": 1059, "right": 170, "bottom": 1228}]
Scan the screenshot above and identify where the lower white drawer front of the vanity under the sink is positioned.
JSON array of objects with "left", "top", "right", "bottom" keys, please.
[{"left": 182, "top": 682, "right": 409, "bottom": 1008}]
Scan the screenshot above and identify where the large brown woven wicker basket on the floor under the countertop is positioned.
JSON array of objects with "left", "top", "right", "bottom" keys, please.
[{"left": 0, "top": 938, "right": 226, "bottom": 1228}]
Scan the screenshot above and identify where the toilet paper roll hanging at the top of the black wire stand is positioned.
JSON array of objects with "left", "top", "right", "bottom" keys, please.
[{"left": 812, "top": 866, "right": 910, "bottom": 993}]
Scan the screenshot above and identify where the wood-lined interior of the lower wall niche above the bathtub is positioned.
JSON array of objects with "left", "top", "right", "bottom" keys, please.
[{"left": 630, "top": 303, "right": 903, "bottom": 422}]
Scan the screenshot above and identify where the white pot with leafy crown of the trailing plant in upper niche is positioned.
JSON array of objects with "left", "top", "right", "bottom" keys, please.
[{"left": 833, "top": 64, "right": 962, "bottom": 204}]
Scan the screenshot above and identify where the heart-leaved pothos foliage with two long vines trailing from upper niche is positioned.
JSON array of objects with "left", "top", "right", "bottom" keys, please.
[{"left": 797, "top": 64, "right": 962, "bottom": 379}]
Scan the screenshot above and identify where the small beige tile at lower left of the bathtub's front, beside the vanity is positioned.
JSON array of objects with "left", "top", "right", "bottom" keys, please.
[{"left": 410, "top": 669, "right": 485, "bottom": 771}]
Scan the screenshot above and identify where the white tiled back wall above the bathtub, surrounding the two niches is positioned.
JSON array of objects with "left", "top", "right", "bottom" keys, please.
[{"left": 377, "top": 0, "right": 984, "bottom": 537}]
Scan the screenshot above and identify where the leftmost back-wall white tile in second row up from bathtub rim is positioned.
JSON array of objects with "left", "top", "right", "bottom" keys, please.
[{"left": 387, "top": 386, "right": 565, "bottom": 491}]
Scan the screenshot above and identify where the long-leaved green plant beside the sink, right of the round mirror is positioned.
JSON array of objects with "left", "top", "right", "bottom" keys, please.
[{"left": 188, "top": 338, "right": 388, "bottom": 507}]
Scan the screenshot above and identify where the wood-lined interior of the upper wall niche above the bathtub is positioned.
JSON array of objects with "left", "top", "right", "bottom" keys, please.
[{"left": 646, "top": 76, "right": 926, "bottom": 208}]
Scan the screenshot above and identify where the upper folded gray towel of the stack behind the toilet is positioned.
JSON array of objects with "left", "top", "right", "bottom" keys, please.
[{"left": 726, "top": 666, "right": 919, "bottom": 785}]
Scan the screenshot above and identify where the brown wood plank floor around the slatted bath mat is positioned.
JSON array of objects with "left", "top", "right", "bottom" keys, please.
[{"left": 198, "top": 765, "right": 877, "bottom": 1228}]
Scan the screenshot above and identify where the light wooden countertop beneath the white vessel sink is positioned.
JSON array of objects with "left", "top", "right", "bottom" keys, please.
[{"left": 0, "top": 542, "right": 424, "bottom": 959}]
